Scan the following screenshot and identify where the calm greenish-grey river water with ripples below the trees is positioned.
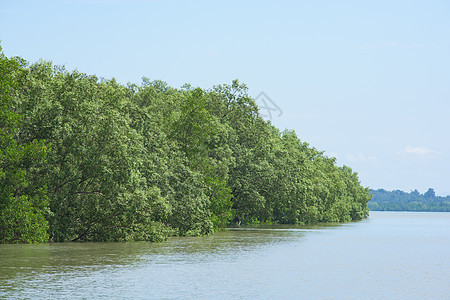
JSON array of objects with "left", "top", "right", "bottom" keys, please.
[{"left": 0, "top": 212, "right": 450, "bottom": 299}]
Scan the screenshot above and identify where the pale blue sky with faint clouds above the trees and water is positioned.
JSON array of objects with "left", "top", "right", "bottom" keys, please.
[{"left": 0, "top": 0, "right": 450, "bottom": 196}]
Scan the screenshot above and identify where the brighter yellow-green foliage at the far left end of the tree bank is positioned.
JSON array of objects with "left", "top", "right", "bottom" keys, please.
[{"left": 0, "top": 47, "right": 48, "bottom": 243}]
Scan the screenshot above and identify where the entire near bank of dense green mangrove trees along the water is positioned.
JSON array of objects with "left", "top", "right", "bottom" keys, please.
[{"left": 0, "top": 47, "right": 370, "bottom": 243}]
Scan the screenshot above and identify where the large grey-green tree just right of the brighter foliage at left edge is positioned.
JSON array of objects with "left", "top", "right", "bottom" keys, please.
[{"left": 14, "top": 62, "right": 171, "bottom": 241}]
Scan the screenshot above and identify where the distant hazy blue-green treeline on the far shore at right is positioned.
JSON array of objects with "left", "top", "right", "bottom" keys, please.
[{"left": 367, "top": 188, "right": 450, "bottom": 212}]
